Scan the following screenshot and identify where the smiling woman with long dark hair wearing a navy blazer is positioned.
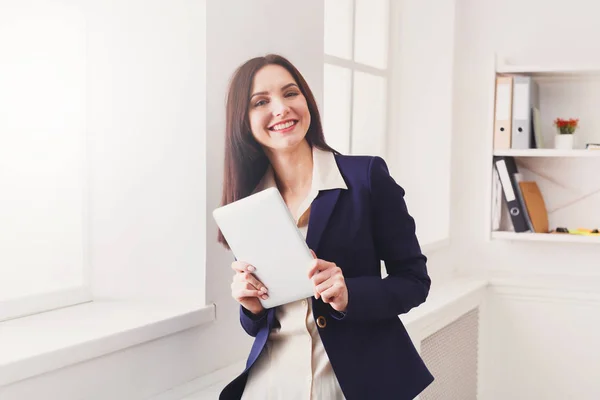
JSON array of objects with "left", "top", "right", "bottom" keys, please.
[{"left": 219, "top": 55, "right": 433, "bottom": 400}]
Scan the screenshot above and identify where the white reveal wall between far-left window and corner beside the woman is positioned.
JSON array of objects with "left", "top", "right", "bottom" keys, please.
[{"left": 86, "top": 0, "right": 206, "bottom": 302}]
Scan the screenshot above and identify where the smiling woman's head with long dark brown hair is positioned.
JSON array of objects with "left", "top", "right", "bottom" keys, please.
[{"left": 219, "top": 55, "right": 337, "bottom": 222}]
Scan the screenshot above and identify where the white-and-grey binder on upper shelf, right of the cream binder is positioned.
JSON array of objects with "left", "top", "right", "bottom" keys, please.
[{"left": 511, "top": 76, "right": 541, "bottom": 149}]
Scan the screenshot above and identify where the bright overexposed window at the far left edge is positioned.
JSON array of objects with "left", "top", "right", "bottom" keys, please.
[{"left": 0, "top": 3, "right": 90, "bottom": 321}]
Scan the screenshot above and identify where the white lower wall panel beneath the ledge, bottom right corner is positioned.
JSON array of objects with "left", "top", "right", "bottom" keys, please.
[{"left": 480, "top": 286, "right": 600, "bottom": 400}]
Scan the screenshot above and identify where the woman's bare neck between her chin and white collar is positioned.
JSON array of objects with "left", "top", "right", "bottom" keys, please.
[{"left": 267, "top": 140, "right": 313, "bottom": 196}]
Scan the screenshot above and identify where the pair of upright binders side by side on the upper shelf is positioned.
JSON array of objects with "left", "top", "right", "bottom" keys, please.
[{"left": 494, "top": 75, "right": 543, "bottom": 150}]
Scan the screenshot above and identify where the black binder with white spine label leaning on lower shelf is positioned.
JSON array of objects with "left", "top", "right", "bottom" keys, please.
[{"left": 494, "top": 156, "right": 531, "bottom": 232}]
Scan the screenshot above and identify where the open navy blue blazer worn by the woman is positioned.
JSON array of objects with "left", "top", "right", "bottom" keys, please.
[{"left": 219, "top": 155, "right": 434, "bottom": 400}]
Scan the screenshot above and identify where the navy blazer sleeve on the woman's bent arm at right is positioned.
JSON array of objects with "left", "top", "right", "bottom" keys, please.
[{"left": 340, "top": 157, "right": 431, "bottom": 321}]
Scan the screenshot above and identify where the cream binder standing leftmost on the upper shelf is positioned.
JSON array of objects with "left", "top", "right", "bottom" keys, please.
[{"left": 494, "top": 76, "right": 513, "bottom": 150}]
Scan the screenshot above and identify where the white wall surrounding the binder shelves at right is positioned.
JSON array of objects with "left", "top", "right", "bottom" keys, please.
[{"left": 452, "top": 0, "right": 600, "bottom": 399}]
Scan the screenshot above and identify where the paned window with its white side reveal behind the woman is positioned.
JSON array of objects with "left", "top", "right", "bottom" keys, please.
[{"left": 323, "top": 0, "right": 454, "bottom": 251}]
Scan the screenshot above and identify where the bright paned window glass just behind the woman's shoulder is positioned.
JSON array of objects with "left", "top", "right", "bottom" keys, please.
[{"left": 323, "top": 0, "right": 391, "bottom": 156}]
